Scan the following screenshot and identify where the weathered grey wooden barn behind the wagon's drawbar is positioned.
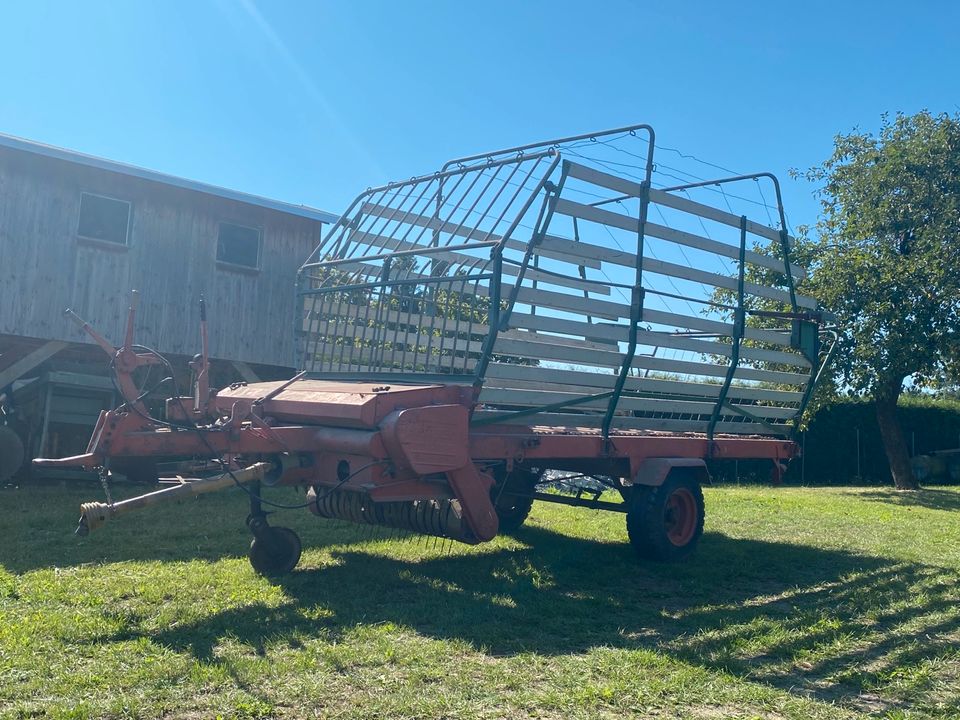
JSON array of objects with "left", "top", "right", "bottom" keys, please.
[{"left": 0, "top": 135, "right": 337, "bottom": 481}]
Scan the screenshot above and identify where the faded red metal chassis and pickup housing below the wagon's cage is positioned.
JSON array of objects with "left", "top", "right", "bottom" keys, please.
[{"left": 36, "top": 379, "right": 796, "bottom": 542}]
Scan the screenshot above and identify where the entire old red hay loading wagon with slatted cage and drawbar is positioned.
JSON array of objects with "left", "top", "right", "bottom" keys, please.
[{"left": 34, "top": 125, "right": 830, "bottom": 574}]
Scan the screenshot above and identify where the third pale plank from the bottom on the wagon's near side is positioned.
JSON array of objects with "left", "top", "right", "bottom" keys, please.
[{"left": 487, "top": 363, "right": 803, "bottom": 404}]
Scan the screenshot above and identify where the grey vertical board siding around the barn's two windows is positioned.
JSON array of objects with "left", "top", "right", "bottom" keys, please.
[{"left": 0, "top": 147, "right": 321, "bottom": 366}]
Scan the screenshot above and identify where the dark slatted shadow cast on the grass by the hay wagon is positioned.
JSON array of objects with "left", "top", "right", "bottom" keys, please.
[{"left": 118, "top": 528, "right": 960, "bottom": 704}]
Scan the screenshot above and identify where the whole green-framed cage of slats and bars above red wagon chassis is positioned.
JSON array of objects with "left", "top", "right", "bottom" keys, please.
[{"left": 298, "top": 126, "right": 819, "bottom": 435}]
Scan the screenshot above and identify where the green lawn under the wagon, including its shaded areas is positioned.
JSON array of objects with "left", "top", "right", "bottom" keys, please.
[{"left": 0, "top": 478, "right": 960, "bottom": 720}]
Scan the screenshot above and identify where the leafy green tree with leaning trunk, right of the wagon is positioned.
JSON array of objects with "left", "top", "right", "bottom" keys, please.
[{"left": 795, "top": 111, "right": 960, "bottom": 489}]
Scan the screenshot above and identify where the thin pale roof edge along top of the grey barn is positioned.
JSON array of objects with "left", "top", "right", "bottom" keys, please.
[{"left": 0, "top": 133, "right": 339, "bottom": 223}]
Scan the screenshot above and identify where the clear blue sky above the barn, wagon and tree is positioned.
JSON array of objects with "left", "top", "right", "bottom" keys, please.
[{"left": 0, "top": 0, "right": 960, "bottom": 231}]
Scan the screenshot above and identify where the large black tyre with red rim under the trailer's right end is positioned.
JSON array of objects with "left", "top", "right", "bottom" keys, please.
[{"left": 627, "top": 472, "right": 704, "bottom": 562}]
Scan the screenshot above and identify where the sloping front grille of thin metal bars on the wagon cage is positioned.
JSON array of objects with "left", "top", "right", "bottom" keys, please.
[{"left": 299, "top": 151, "right": 559, "bottom": 381}]
